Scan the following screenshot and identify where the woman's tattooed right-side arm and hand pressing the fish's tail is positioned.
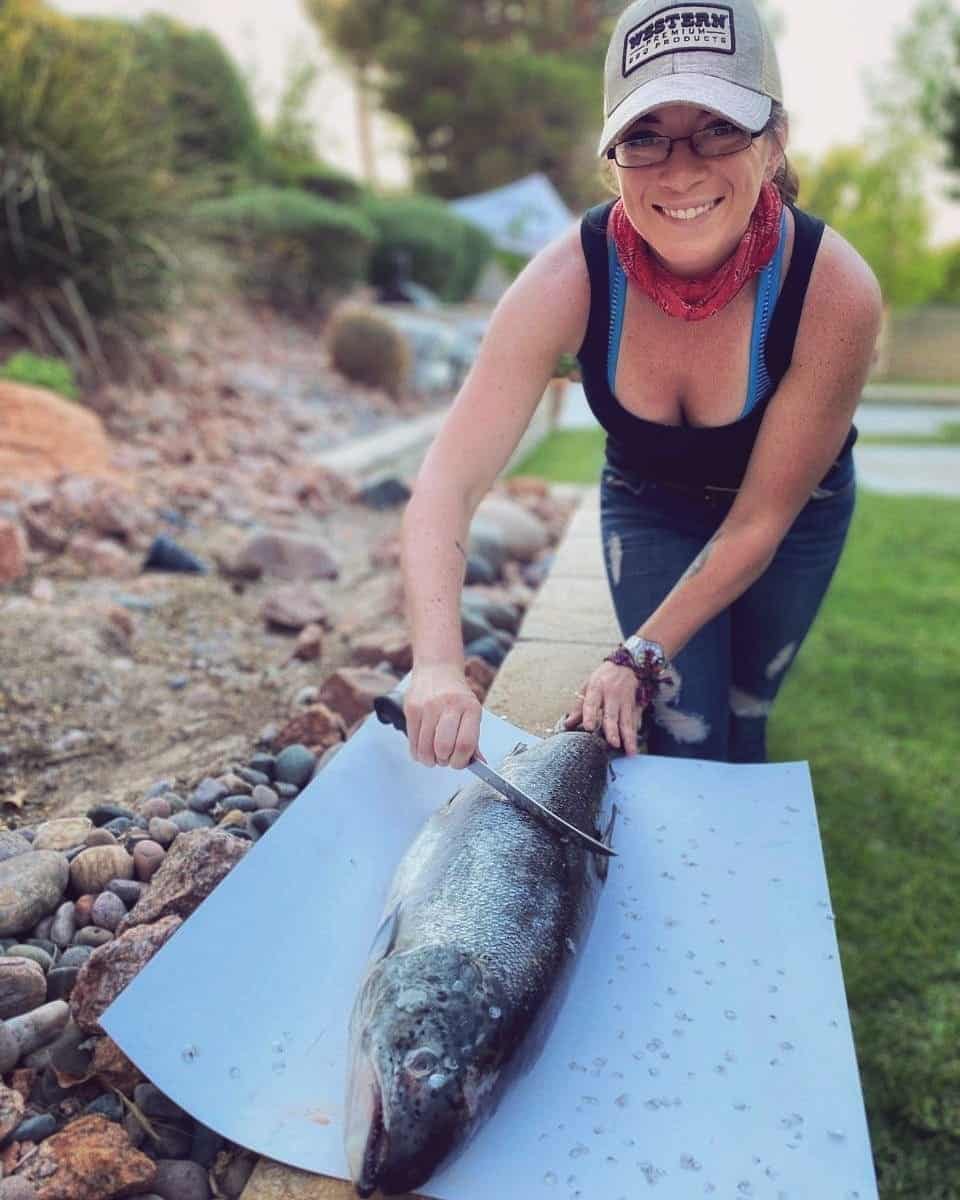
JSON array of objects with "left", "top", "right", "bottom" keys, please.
[{"left": 568, "top": 229, "right": 882, "bottom": 752}]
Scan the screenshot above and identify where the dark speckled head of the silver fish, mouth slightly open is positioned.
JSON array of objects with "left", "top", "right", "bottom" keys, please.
[{"left": 346, "top": 946, "right": 510, "bottom": 1195}]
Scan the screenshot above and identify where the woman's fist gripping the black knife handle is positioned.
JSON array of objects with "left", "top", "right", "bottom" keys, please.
[{"left": 403, "top": 664, "right": 482, "bottom": 768}]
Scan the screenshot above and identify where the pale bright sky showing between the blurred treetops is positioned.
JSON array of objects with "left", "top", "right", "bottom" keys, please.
[{"left": 53, "top": 0, "right": 960, "bottom": 242}]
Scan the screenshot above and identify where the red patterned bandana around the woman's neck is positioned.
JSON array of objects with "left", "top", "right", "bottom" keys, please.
[{"left": 610, "top": 184, "right": 784, "bottom": 320}]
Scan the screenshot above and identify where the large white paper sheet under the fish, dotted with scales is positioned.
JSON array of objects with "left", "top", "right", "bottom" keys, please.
[{"left": 101, "top": 713, "right": 877, "bottom": 1200}]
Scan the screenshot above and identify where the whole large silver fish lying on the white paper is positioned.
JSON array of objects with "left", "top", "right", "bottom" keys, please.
[{"left": 346, "top": 732, "right": 608, "bottom": 1196}]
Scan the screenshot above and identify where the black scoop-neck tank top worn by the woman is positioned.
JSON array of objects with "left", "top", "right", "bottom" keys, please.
[{"left": 577, "top": 198, "right": 857, "bottom": 488}]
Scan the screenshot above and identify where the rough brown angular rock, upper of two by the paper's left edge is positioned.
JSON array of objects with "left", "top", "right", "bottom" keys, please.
[{"left": 117, "top": 829, "right": 247, "bottom": 931}]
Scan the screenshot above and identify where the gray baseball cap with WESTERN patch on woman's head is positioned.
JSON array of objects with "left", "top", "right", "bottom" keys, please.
[{"left": 596, "top": 0, "right": 782, "bottom": 157}]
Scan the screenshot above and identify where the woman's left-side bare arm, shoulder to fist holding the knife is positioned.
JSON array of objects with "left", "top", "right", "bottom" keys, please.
[{"left": 402, "top": 226, "right": 589, "bottom": 767}]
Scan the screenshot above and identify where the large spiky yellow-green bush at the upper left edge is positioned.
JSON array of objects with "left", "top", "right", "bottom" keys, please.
[{"left": 0, "top": 0, "right": 182, "bottom": 370}]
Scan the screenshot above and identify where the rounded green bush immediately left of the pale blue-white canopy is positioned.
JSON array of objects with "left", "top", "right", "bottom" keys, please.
[{"left": 361, "top": 196, "right": 493, "bottom": 301}]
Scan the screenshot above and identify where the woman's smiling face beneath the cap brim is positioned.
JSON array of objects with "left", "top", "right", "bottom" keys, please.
[{"left": 614, "top": 104, "right": 782, "bottom": 277}]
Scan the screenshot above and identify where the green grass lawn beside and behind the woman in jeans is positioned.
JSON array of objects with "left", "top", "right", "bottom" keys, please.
[{"left": 518, "top": 431, "right": 960, "bottom": 1200}]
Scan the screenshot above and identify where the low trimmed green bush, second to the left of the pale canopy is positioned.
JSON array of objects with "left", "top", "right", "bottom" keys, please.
[{"left": 194, "top": 187, "right": 376, "bottom": 312}]
